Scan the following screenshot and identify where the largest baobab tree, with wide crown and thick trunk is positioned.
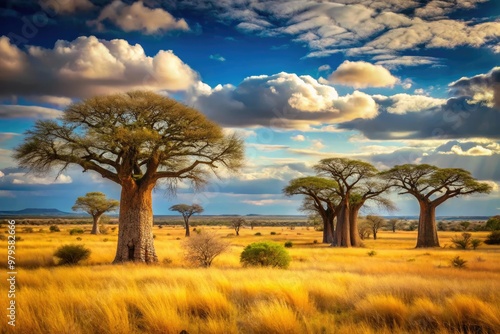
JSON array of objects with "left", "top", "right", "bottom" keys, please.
[{"left": 15, "top": 91, "right": 243, "bottom": 263}]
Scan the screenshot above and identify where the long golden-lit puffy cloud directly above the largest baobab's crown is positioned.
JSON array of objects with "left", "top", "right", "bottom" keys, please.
[{"left": 0, "top": 36, "right": 198, "bottom": 101}]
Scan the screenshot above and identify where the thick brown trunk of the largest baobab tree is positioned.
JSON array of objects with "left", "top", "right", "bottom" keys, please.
[{"left": 113, "top": 184, "right": 158, "bottom": 263}]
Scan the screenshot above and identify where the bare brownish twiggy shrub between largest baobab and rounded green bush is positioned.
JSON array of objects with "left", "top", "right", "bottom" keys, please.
[{"left": 183, "top": 230, "right": 229, "bottom": 268}]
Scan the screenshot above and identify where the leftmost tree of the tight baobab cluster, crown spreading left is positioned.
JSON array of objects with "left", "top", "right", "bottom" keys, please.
[{"left": 283, "top": 176, "right": 337, "bottom": 244}]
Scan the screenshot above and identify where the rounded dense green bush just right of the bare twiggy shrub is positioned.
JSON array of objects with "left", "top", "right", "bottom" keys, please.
[{"left": 240, "top": 242, "right": 291, "bottom": 268}]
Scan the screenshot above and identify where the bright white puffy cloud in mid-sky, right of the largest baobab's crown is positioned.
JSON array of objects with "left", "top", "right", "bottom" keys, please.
[{"left": 191, "top": 72, "right": 377, "bottom": 129}]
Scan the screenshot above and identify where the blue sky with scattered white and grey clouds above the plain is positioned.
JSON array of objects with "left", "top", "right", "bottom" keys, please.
[{"left": 0, "top": 0, "right": 500, "bottom": 216}]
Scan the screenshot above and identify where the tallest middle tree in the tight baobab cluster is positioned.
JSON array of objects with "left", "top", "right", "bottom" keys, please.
[{"left": 314, "top": 158, "right": 378, "bottom": 247}]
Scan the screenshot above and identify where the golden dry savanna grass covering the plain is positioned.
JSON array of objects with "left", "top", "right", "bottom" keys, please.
[{"left": 0, "top": 226, "right": 500, "bottom": 334}]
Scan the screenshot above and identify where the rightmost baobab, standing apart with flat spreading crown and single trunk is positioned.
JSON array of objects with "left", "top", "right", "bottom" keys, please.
[{"left": 382, "top": 164, "right": 491, "bottom": 248}]
